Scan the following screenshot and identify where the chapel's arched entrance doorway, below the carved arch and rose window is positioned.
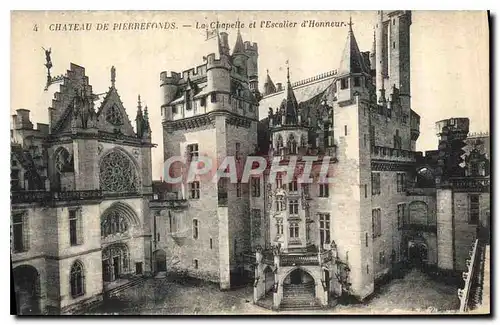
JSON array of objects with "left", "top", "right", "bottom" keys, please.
[{"left": 102, "top": 243, "right": 130, "bottom": 282}]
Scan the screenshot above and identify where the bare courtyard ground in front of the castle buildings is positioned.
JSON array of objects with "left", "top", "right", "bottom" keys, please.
[{"left": 87, "top": 270, "right": 459, "bottom": 315}]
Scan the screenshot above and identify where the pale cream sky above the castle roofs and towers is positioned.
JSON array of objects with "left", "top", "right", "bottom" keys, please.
[{"left": 10, "top": 11, "right": 489, "bottom": 179}]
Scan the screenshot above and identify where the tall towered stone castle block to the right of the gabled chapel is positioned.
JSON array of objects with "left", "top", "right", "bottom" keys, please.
[{"left": 152, "top": 11, "right": 489, "bottom": 308}]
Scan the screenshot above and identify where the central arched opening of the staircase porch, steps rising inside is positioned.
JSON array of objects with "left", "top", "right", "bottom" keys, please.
[{"left": 282, "top": 268, "right": 316, "bottom": 307}]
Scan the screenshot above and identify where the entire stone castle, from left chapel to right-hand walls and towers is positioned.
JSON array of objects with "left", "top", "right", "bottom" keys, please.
[{"left": 11, "top": 11, "right": 490, "bottom": 313}]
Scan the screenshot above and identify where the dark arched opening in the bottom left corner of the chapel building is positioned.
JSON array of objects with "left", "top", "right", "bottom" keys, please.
[{"left": 13, "top": 265, "right": 41, "bottom": 315}]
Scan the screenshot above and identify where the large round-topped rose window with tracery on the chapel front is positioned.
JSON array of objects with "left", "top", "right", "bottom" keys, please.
[{"left": 99, "top": 151, "right": 138, "bottom": 193}]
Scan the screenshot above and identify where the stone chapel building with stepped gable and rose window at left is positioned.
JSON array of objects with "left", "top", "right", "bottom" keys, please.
[{"left": 11, "top": 64, "right": 152, "bottom": 314}]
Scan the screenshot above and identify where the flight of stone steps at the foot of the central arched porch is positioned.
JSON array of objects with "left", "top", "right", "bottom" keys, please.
[{"left": 280, "top": 282, "right": 322, "bottom": 310}]
